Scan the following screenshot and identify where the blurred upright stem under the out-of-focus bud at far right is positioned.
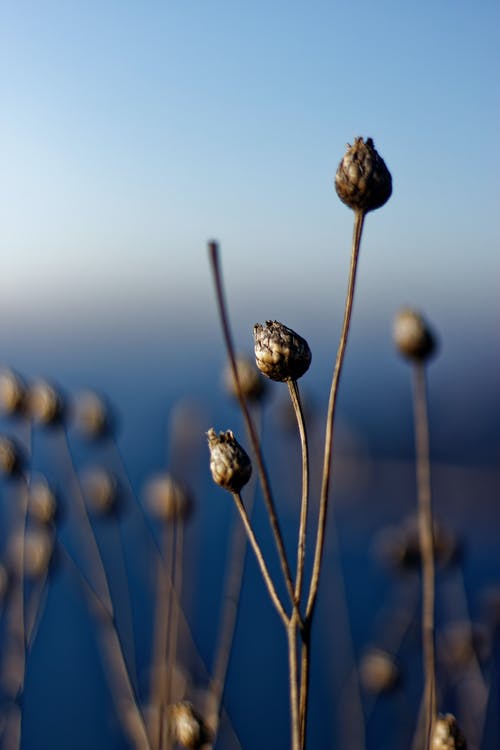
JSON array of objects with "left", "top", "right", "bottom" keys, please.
[{"left": 413, "top": 362, "right": 436, "bottom": 748}]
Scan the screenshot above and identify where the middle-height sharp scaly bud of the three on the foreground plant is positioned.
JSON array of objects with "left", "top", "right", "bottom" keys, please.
[{"left": 253, "top": 320, "right": 311, "bottom": 383}]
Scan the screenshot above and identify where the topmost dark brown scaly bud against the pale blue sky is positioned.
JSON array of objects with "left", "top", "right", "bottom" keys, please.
[{"left": 335, "top": 138, "right": 392, "bottom": 213}]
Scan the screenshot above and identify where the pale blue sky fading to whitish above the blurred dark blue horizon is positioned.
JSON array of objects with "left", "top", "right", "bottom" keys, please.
[{"left": 0, "top": 0, "right": 500, "bottom": 344}]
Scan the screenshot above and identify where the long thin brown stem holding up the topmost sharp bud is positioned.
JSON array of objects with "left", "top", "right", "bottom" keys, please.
[{"left": 306, "top": 211, "right": 365, "bottom": 621}]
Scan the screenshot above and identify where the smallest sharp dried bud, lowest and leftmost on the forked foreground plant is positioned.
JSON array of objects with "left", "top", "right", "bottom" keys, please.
[{"left": 207, "top": 429, "right": 252, "bottom": 492}]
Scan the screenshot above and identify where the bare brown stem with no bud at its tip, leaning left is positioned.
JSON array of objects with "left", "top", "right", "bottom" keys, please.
[{"left": 208, "top": 242, "right": 297, "bottom": 607}]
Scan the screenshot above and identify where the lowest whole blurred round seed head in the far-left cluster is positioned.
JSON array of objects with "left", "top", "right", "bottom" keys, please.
[{"left": 7, "top": 529, "right": 54, "bottom": 579}]
